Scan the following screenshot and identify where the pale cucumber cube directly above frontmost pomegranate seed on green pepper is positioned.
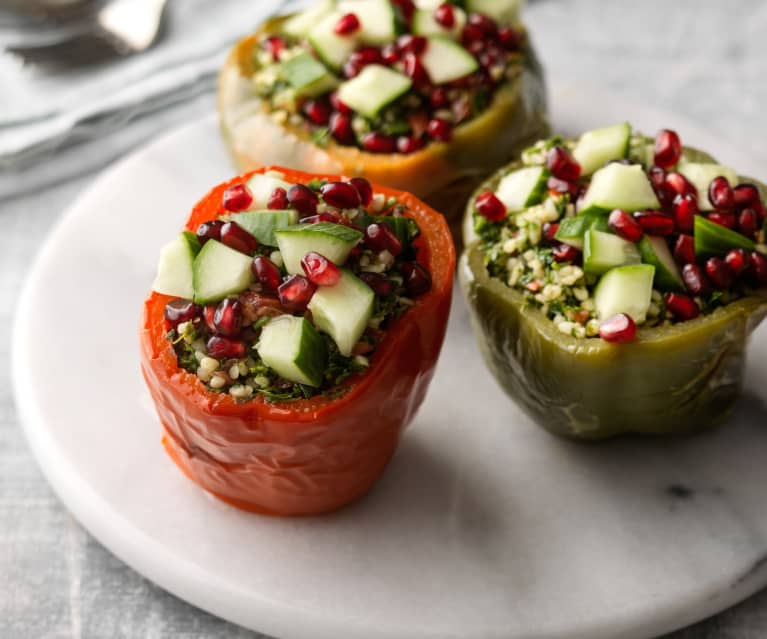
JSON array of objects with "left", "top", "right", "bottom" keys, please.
[{"left": 594, "top": 264, "right": 655, "bottom": 324}]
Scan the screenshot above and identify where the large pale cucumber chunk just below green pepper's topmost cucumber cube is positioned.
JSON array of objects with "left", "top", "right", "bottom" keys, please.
[{"left": 579, "top": 162, "right": 660, "bottom": 214}]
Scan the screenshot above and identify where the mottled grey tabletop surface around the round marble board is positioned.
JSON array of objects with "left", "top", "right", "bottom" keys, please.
[{"left": 0, "top": 0, "right": 767, "bottom": 639}]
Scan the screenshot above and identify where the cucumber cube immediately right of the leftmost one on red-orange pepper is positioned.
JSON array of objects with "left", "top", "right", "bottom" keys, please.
[{"left": 192, "top": 240, "right": 253, "bottom": 304}]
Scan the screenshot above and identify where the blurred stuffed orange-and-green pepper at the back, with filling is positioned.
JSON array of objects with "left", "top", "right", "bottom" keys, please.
[{"left": 218, "top": 0, "right": 548, "bottom": 232}]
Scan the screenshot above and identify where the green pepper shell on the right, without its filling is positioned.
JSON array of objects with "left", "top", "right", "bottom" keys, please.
[{"left": 458, "top": 149, "right": 767, "bottom": 440}]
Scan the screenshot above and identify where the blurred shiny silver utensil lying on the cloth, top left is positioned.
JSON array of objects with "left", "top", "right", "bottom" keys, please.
[{"left": 6, "top": 0, "right": 167, "bottom": 69}]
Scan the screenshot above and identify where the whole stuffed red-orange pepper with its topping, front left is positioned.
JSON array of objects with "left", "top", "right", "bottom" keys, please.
[{"left": 141, "top": 168, "right": 455, "bottom": 515}]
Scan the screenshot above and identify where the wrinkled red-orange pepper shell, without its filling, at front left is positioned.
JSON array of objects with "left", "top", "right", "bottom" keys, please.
[{"left": 140, "top": 167, "right": 455, "bottom": 515}]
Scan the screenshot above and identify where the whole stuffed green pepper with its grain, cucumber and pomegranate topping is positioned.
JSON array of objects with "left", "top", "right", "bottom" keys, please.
[{"left": 459, "top": 123, "right": 767, "bottom": 439}]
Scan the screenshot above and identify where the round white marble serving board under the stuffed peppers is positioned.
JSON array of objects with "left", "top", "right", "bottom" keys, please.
[{"left": 13, "top": 87, "right": 767, "bottom": 639}]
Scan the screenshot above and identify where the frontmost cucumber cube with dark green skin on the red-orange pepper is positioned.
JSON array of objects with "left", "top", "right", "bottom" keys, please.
[{"left": 256, "top": 315, "right": 328, "bottom": 387}]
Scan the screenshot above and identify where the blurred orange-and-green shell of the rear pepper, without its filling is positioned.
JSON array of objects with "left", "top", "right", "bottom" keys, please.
[{"left": 218, "top": 16, "right": 549, "bottom": 236}]
